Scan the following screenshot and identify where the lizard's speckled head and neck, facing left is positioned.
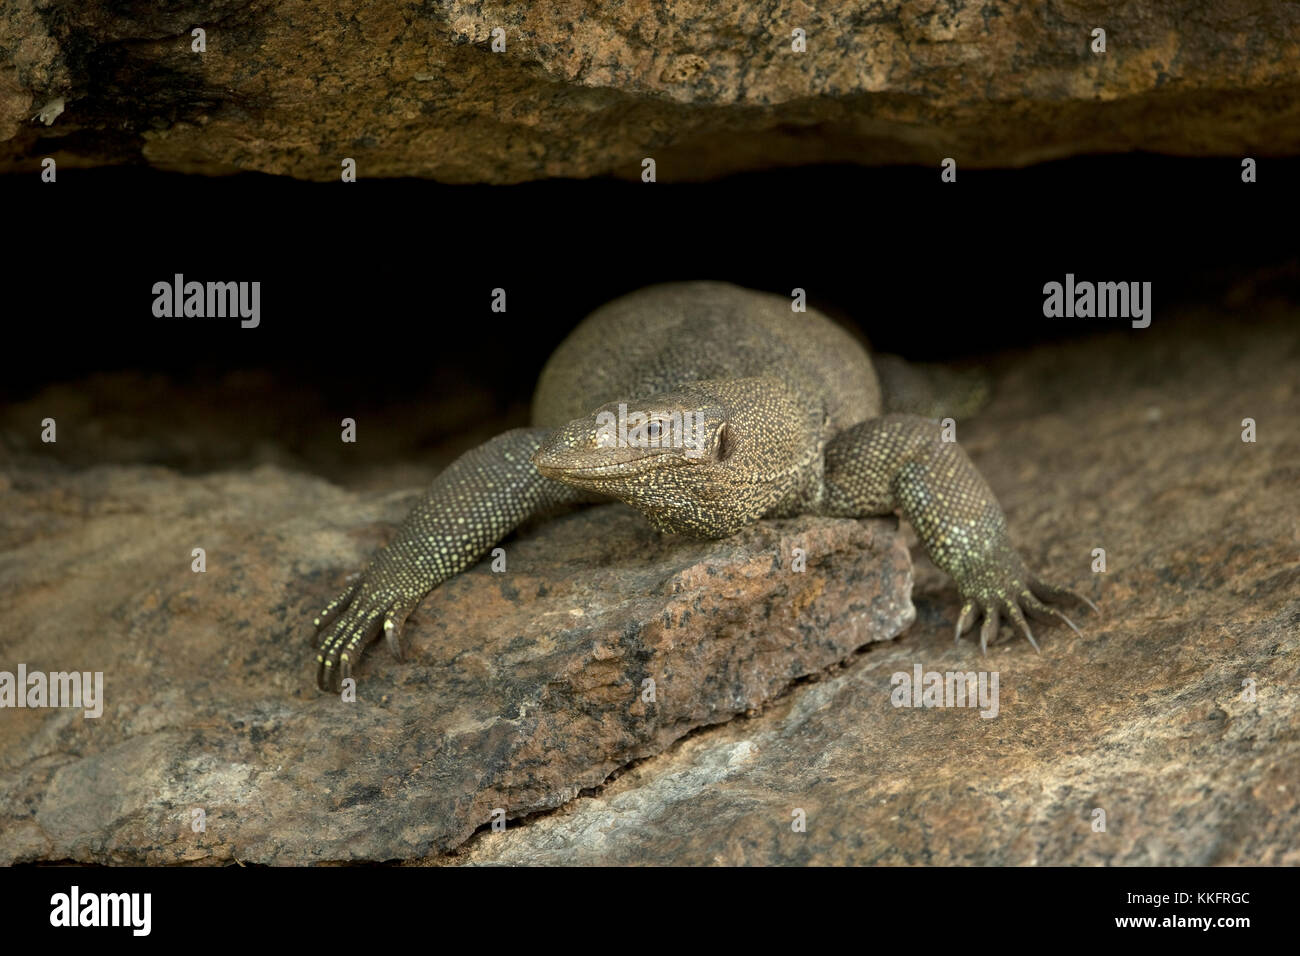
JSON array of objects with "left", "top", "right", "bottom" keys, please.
[{"left": 533, "top": 378, "right": 822, "bottom": 537}]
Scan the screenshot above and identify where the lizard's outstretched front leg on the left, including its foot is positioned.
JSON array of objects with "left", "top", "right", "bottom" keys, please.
[{"left": 313, "top": 428, "right": 592, "bottom": 691}]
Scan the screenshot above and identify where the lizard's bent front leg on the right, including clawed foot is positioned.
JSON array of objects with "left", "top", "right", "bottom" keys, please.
[{"left": 823, "top": 415, "right": 1096, "bottom": 653}]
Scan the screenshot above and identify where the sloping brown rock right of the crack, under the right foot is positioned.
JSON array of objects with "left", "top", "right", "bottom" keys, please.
[{"left": 438, "top": 303, "right": 1300, "bottom": 866}]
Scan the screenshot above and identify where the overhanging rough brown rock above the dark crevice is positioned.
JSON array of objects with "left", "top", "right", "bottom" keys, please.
[{"left": 0, "top": 0, "right": 1300, "bottom": 182}]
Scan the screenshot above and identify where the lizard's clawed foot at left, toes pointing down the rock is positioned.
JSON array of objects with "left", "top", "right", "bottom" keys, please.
[{"left": 312, "top": 574, "right": 411, "bottom": 691}]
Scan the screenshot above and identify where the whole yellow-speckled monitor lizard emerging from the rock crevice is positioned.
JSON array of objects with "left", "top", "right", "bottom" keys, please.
[{"left": 315, "top": 282, "right": 1091, "bottom": 689}]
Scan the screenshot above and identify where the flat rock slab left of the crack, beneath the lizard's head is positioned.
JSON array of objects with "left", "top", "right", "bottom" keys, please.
[{"left": 0, "top": 470, "right": 914, "bottom": 864}]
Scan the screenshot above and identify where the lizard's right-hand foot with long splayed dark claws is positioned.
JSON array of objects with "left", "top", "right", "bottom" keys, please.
[{"left": 954, "top": 554, "right": 1097, "bottom": 654}]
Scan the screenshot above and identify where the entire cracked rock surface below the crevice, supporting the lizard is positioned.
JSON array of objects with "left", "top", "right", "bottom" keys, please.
[{"left": 0, "top": 287, "right": 1300, "bottom": 865}]
